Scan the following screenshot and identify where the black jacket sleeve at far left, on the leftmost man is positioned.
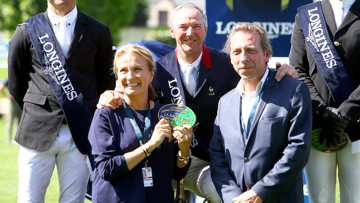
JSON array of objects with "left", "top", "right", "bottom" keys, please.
[{"left": 8, "top": 25, "right": 32, "bottom": 109}]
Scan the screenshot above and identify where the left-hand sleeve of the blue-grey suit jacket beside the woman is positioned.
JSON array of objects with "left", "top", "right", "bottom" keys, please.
[{"left": 209, "top": 100, "right": 242, "bottom": 202}]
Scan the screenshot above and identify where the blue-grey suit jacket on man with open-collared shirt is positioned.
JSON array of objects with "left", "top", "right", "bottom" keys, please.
[{"left": 209, "top": 71, "right": 312, "bottom": 203}]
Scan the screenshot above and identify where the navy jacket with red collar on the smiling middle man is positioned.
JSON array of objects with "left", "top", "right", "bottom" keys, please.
[{"left": 152, "top": 46, "right": 240, "bottom": 161}]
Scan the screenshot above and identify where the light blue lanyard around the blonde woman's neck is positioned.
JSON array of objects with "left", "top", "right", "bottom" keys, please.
[{"left": 122, "top": 96, "right": 151, "bottom": 144}]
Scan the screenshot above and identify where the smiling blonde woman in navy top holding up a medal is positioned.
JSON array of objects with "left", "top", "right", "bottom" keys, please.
[{"left": 89, "top": 45, "right": 192, "bottom": 203}]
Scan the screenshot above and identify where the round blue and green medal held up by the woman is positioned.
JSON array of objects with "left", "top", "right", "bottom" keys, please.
[{"left": 158, "top": 104, "right": 196, "bottom": 128}]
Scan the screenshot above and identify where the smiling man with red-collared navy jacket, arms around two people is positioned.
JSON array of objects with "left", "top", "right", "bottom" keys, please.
[{"left": 98, "top": 3, "right": 297, "bottom": 203}]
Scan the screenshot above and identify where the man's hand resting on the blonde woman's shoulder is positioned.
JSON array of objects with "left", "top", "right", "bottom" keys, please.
[{"left": 96, "top": 90, "right": 122, "bottom": 110}]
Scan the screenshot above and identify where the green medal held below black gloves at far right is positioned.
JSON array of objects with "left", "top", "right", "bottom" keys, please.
[{"left": 311, "top": 128, "right": 349, "bottom": 153}]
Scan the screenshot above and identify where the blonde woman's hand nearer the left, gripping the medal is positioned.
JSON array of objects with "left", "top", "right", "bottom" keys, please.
[{"left": 146, "top": 119, "right": 172, "bottom": 151}]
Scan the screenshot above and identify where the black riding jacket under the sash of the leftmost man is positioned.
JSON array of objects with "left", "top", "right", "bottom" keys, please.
[{"left": 8, "top": 8, "right": 115, "bottom": 153}]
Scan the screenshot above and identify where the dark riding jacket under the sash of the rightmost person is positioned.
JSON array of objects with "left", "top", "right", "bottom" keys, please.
[{"left": 289, "top": 0, "right": 360, "bottom": 141}]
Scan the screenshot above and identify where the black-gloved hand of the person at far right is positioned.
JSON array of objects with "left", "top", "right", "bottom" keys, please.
[{"left": 316, "top": 105, "right": 350, "bottom": 147}]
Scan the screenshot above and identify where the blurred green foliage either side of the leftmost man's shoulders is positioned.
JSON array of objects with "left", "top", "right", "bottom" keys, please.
[{"left": 0, "top": 0, "right": 139, "bottom": 44}]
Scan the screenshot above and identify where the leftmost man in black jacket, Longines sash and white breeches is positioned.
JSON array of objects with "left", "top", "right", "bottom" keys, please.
[{"left": 8, "top": 0, "right": 115, "bottom": 202}]
